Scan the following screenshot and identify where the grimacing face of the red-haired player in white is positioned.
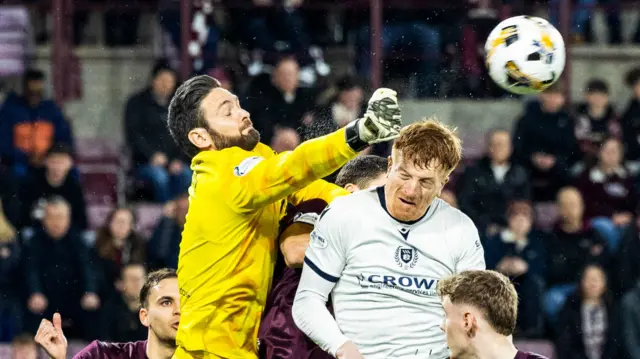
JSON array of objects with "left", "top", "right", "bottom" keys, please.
[{"left": 385, "top": 151, "right": 448, "bottom": 222}]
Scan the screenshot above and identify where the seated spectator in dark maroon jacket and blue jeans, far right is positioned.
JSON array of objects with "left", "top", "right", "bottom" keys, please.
[{"left": 576, "top": 138, "right": 638, "bottom": 252}]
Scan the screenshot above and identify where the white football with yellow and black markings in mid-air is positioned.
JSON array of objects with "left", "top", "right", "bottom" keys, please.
[{"left": 484, "top": 16, "right": 565, "bottom": 95}]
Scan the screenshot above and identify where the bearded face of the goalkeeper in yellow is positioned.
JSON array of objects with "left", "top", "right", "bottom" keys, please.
[{"left": 198, "top": 88, "right": 260, "bottom": 151}]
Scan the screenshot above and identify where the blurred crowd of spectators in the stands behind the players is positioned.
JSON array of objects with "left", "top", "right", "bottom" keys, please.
[{"left": 0, "top": 1, "right": 640, "bottom": 359}]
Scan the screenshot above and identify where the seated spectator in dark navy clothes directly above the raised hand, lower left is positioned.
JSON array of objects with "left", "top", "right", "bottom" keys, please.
[{"left": 24, "top": 196, "right": 100, "bottom": 340}]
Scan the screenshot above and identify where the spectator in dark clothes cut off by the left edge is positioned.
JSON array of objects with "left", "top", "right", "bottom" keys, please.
[{"left": 0, "top": 205, "right": 22, "bottom": 343}]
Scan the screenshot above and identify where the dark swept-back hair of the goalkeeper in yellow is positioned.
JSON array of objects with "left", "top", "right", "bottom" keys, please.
[{"left": 167, "top": 75, "right": 220, "bottom": 157}]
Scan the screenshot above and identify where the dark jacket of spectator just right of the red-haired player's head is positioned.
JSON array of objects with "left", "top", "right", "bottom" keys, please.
[{"left": 456, "top": 158, "right": 531, "bottom": 233}]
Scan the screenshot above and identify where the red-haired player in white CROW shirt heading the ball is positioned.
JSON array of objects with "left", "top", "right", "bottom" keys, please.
[{"left": 293, "top": 120, "right": 485, "bottom": 359}]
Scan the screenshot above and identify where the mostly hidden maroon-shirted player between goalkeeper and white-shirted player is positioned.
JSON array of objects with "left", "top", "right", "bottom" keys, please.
[{"left": 259, "top": 155, "right": 387, "bottom": 359}]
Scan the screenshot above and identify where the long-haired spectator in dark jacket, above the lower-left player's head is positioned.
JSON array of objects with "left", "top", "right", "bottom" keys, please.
[{"left": 95, "top": 207, "right": 146, "bottom": 298}]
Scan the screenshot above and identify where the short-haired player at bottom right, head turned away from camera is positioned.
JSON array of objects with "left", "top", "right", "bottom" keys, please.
[{"left": 437, "top": 270, "right": 546, "bottom": 359}]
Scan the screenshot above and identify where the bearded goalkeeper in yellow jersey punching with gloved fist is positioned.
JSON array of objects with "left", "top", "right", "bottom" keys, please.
[{"left": 168, "top": 76, "right": 401, "bottom": 359}]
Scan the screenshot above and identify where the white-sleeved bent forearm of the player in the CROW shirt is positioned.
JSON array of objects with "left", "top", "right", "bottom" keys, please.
[{"left": 292, "top": 267, "right": 349, "bottom": 355}]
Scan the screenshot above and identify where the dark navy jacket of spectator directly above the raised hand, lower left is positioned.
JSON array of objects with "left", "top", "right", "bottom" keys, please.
[{"left": 24, "top": 228, "right": 98, "bottom": 312}]
